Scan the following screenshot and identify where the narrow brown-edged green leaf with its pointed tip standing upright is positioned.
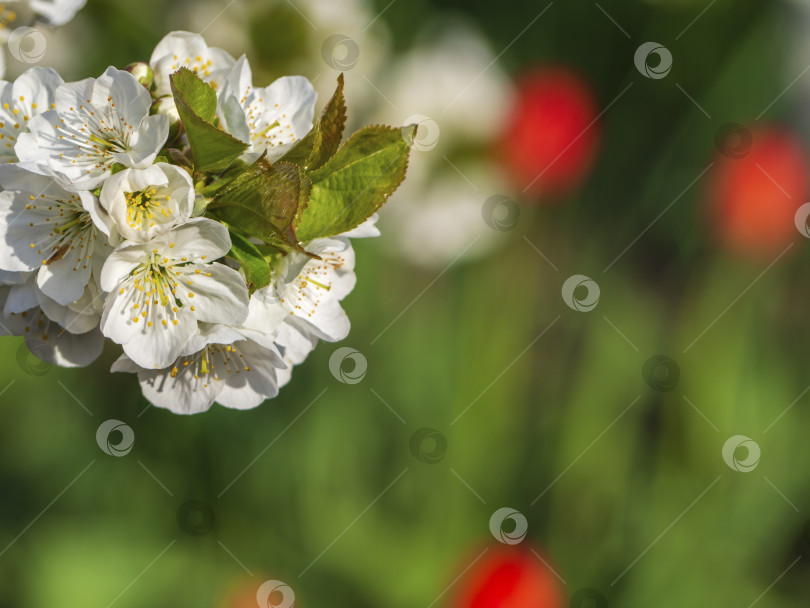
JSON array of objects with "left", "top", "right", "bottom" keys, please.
[{"left": 282, "top": 74, "right": 346, "bottom": 171}]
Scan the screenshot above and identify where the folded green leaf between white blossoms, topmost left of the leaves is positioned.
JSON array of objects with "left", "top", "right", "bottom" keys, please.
[{"left": 171, "top": 68, "right": 247, "bottom": 171}]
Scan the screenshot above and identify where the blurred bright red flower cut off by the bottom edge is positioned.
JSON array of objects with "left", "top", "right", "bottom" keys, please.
[{"left": 453, "top": 545, "right": 565, "bottom": 608}]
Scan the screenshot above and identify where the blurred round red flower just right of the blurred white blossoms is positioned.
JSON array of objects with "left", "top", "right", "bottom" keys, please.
[{"left": 502, "top": 65, "right": 599, "bottom": 202}]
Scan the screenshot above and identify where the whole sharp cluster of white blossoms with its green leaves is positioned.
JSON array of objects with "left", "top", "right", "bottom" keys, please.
[{"left": 0, "top": 32, "right": 414, "bottom": 414}]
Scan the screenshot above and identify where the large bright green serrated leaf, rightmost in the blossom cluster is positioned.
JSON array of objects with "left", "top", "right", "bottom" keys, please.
[{"left": 296, "top": 125, "right": 416, "bottom": 242}]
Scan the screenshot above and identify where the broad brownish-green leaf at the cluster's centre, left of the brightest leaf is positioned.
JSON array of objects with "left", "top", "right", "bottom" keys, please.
[{"left": 206, "top": 157, "right": 309, "bottom": 253}]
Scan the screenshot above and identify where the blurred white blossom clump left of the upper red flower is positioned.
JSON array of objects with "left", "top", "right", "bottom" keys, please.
[{"left": 370, "top": 21, "right": 513, "bottom": 268}]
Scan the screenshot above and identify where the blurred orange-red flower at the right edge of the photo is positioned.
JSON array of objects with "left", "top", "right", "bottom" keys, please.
[{"left": 707, "top": 125, "right": 808, "bottom": 257}]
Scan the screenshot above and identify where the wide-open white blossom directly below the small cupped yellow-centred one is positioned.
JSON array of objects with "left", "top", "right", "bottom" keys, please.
[{"left": 101, "top": 218, "right": 248, "bottom": 369}]
